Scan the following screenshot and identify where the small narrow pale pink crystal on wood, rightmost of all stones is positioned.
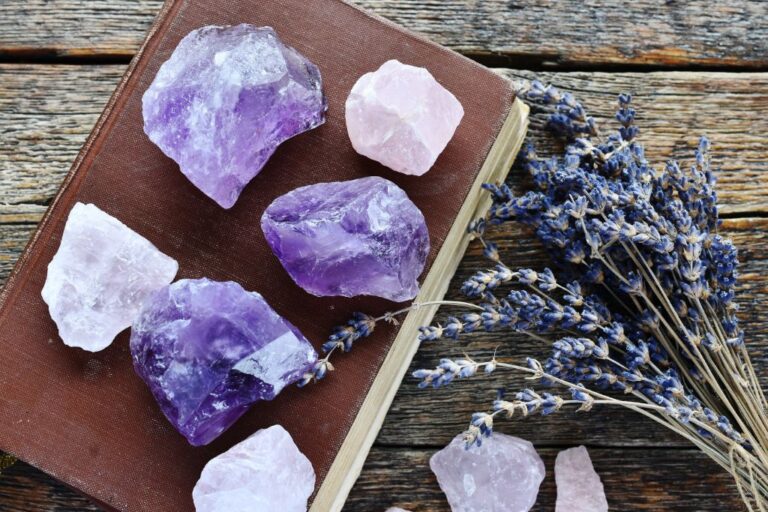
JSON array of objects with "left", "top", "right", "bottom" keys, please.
[{"left": 555, "top": 446, "right": 608, "bottom": 512}]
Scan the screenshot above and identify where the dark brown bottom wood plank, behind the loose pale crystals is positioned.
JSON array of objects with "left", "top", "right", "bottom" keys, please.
[{"left": 0, "top": 447, "right": 742, "bottom": 512}]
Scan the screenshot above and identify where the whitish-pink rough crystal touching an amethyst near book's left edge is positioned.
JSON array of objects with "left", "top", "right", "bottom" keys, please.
[{"left": 42, "top": 203, "right": 179, "bottom": 352}]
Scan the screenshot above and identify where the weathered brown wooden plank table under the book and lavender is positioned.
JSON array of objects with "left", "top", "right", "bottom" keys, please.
[{"left": 0, "top": 0, "right": 768, "bottom": 512}]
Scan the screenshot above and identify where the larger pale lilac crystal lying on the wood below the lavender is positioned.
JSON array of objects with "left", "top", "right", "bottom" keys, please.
[{"left": 429, "top": 433, "right": 545, "bottom": 512}]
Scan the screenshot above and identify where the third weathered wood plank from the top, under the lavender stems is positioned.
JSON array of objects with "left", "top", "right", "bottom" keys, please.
[{"left": 0, "top": 219, "right": 768, "bottom": 447}]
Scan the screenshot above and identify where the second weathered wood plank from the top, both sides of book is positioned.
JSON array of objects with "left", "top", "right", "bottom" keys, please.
[{"left": 0, "top": 64, "right": 768, "bottom": 221}]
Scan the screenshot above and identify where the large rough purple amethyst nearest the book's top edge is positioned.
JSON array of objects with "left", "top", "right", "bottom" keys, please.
[{"left": 143, "top": 24, "right": 326, "bottom": 208}]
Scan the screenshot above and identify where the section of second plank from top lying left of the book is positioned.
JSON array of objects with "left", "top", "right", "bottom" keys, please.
[{"left": 0, "top": 65, "right": 124, "bottom": 222}]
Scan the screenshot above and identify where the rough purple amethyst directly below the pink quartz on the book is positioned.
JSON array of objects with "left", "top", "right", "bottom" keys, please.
[{"left": 261, "top": 177, "right": 429, "bottom": 301}]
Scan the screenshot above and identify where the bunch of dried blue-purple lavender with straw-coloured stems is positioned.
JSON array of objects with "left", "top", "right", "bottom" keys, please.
[{"left": 312, "top": 81, "right": 768, "bottom": 511}]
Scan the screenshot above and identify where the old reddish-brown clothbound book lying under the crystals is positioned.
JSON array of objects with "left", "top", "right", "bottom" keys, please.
[{"left": 0, "top": 0, "right": 527, "bottom": 512}]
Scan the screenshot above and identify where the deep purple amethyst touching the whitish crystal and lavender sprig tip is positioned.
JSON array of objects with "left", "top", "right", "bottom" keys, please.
[{"left": 131, "top": 279, "right": 317, "bottom": 446}]
